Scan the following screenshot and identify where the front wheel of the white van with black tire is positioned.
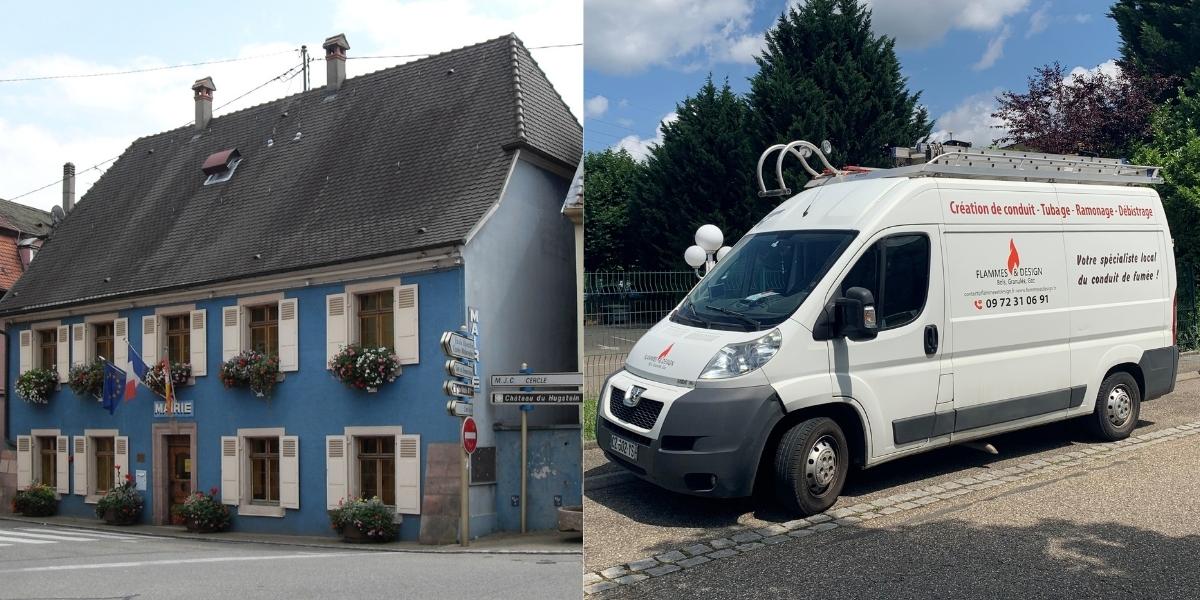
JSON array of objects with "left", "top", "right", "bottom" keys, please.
[{"left": 775, "top": 416, "right": 850, "bottom": 516}]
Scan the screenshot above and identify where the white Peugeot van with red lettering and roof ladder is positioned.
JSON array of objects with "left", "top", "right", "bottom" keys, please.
[{"left": 596, "top": 142, "right": 1178, "bottom": 515}]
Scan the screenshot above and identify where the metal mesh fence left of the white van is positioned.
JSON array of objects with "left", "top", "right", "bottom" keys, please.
[{"left": 583, "top": 271, "right": 700, "bottom": 397}]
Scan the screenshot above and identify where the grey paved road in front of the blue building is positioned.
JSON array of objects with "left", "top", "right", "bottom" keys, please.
[{"left": 0, "top": 521, "right": 581, "bottom": 600}]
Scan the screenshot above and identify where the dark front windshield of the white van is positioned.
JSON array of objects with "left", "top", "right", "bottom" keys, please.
[{"left": 671, "top": 230, "right": 856, "bottom": 331}]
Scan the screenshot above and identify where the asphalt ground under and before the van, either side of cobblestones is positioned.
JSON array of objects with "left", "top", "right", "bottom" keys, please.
[{"left": 584, "top": 380, "right": 1200, "bottom": 598}]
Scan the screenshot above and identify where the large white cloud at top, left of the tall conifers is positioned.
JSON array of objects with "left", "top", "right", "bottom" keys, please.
[{"left": 583, "top": 0, "right": 762, "bottom": 74}]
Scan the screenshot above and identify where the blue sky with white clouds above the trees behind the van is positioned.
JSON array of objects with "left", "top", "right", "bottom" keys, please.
[{"left": 584, "top": 0, "right": 1120, "bottom": 157}]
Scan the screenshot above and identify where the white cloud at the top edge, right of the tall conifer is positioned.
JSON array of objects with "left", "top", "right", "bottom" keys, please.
[{"left": 865, "top": 0, "right": 1030, "bottom": 48}]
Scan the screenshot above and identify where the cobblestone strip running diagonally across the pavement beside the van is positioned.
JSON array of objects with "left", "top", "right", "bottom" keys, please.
[{"left": 583, "top": 421, "right": 1200, "bottom": 594}]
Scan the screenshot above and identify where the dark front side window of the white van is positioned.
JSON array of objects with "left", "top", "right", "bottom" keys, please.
[{"left": 841, "top": 234, "right": 929, "bottom": 331}]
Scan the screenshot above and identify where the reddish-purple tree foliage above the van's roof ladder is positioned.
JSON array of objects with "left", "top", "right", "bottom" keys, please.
[{"left": 992, "top": 62, "right": 1154, "bottom": 156}]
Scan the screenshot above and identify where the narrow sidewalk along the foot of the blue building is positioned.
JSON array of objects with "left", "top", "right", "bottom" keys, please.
[{"left": 0, "top": 515, "right": 583, "bottom": 554}]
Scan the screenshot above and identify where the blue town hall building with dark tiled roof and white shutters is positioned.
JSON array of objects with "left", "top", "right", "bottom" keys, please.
[{"left": 0, "top": 36, "right": 582, "bottom": 541}]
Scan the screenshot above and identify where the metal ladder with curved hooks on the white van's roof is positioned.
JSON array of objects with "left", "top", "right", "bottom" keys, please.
[{"left": 758, "top": 140, "right": 1163, "bottom": 197}]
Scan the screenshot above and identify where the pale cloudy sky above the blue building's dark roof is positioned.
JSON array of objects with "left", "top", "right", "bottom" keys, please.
[{"left": 0, "top": 0, "right": 583, "bottom": 210}]
